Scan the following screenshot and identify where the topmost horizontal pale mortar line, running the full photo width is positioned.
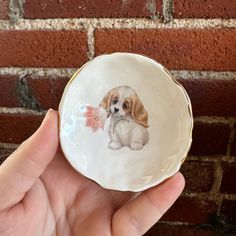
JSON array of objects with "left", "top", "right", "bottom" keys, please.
[{"left": 0, "top": 18, "right": 236, "bottom": 30}]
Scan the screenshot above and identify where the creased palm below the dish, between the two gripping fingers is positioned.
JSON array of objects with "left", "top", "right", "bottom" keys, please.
[{"left": 4, "top": 151, "right": 133, "bottom": 236}]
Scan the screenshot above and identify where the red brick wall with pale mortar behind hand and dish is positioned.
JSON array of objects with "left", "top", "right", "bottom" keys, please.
[{"left": 0, "top": 0, "right": 236, "bottom": 236}]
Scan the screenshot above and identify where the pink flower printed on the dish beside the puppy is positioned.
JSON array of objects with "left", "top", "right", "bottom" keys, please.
[{"left": 85, "top": 106, "right": 106, "bottom": 132}]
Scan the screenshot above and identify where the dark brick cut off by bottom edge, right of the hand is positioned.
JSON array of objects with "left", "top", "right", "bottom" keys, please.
[{"left": 144, "top": 223, "right": 215, "bottom": 236}]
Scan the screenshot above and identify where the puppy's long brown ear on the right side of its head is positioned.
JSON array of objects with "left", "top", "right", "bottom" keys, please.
[{"left": 131, "top": 95, "right": 148, "bottom": 128}]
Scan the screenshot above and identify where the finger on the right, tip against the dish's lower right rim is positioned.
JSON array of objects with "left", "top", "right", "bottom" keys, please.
[{"left": 112, "top": 172, "right": 185, "bottom": 236}]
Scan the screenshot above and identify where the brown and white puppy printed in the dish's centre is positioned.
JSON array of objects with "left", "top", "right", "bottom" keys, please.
[{"left": 99, "top": 86, "right": 149, "bottom": 150}]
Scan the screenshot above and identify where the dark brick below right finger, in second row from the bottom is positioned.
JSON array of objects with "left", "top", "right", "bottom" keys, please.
[{"left": 161, "top": 197, "right": 216, "bottom": 224}]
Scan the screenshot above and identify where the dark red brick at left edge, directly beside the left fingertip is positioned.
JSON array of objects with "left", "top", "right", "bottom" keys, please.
[{"left": 0, "top": 113, "right": 43, "bottom": 143}]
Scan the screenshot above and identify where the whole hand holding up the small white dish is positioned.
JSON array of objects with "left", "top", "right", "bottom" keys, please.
[{"left": 0, "top": 110, "right": 184, "bottom": 236}]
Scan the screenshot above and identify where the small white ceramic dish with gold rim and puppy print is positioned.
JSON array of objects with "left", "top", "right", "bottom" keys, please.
[{"left": 59, "top": 53, "right": 193, "bottom": 192}]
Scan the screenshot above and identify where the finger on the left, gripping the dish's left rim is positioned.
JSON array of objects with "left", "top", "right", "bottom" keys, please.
[{"left": 0, "top": 109, "right": 58, "bottom": 210}]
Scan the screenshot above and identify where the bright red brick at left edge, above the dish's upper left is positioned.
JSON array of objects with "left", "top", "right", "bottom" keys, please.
[{"left": 0, "top": 30, "right": 88, "bottom": 67}]
